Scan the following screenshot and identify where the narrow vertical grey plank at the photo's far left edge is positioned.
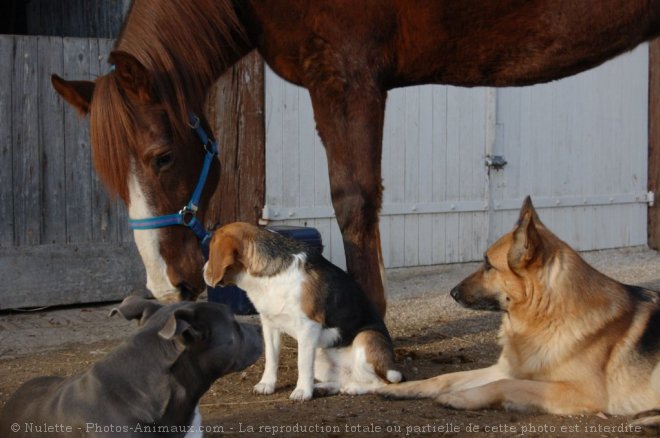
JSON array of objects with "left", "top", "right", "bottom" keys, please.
[{"left": 0, "top": 35, "right": 14, "bottom": 247}]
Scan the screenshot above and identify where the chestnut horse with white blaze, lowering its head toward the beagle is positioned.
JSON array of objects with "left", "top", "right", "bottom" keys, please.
[{"left": 53, "top": 0, "right": 660, "bottom": 314}]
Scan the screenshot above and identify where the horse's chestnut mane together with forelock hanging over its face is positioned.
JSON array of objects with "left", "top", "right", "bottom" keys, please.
[{"left": 90, "top": 0, "right": 249, "bottom": 200}]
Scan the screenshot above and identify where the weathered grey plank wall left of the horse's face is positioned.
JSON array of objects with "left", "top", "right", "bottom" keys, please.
[{"left": 0, "top": 36, "right": 145, "bottom": 309}]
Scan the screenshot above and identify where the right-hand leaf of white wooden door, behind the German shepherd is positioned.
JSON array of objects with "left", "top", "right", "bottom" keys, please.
[{"left": 489, "top": 45, "right": 648, "bottom": 250}]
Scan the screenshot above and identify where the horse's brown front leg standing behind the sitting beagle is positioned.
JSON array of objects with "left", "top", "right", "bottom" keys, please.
[{"left": 310, "top": 80, "right": 386, "bottom": 316}]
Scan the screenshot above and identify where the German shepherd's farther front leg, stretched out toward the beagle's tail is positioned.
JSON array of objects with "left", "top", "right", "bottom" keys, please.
[{"left": 377, "top": 364, "right": 509, "bottom": 399}]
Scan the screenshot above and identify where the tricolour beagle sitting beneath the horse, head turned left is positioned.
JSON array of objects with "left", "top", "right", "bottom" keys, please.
[{"left": 204, "top": 222, "right": 402, "bottom": 400}]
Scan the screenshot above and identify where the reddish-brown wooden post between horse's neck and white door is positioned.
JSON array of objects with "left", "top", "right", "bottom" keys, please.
[{"left": 207, "top": 52, "right": 266, "bottom": 223}]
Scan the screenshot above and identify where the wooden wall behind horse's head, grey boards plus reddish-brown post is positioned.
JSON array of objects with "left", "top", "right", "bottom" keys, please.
[{"left": 0, "top": 35, "right": 265, "bottom": 310}]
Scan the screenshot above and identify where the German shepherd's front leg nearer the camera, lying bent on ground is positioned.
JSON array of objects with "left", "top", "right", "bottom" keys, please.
[{"left": 435, "top": 379, "right": 605, "bottom": 415}]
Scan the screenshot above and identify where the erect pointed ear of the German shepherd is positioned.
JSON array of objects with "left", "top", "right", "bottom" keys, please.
[{"left": 507, "top": 196, "right": 543, "bottom": 271}]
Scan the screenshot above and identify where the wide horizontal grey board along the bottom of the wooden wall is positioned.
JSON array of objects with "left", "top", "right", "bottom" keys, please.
[{"left": 0, "top": 243, "right": 147, "bottom": 310}]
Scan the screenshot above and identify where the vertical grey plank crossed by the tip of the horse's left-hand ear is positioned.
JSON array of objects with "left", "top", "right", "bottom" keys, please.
[{"left": 63, "top": 38, "right": 92, "bottom": 243}]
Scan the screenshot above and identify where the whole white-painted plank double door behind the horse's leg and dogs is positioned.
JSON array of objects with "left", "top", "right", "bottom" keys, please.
[{"left": 266, "top": 46, "right": 648, "bottom": 267}]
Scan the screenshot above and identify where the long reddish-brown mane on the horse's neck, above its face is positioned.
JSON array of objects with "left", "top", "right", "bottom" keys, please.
[{"left": 116, "top": 0, "right": 249, "bottom": 125}]
